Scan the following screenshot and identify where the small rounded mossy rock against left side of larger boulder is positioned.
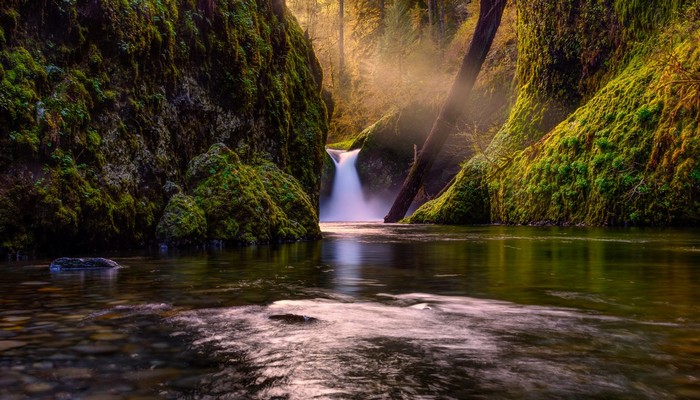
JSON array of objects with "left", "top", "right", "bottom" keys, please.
[{"left": 156, "top": 193, "right": 207, "bottom": 246}]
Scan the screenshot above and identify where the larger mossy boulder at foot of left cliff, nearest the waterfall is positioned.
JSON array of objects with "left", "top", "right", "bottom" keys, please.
[{"left": 187, "top": 144, "right": 319, "bottom": 244}]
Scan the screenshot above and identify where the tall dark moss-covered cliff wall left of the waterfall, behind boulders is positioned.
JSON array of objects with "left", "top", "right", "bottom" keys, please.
[{"left": 0, "top": 0, "right": 327, "bottom": 254}]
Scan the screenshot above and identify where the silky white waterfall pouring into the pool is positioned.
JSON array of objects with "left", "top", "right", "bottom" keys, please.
[{"left": 320, "top": 149, "right": 387, "bottom": 222}]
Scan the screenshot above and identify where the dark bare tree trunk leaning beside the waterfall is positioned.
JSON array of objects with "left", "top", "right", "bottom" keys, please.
[{"left": 384, "top": 0, "right": 506, "bottom": 222}]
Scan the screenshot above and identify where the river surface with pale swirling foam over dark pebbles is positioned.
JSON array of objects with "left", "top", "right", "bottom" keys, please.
[{"left": 0, "top": 223, "right": 700, "bottom": 399}]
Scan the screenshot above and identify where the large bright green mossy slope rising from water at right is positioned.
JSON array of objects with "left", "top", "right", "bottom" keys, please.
[{"left": 491, "top": 20, "right": 700, "bottom": 225}]
